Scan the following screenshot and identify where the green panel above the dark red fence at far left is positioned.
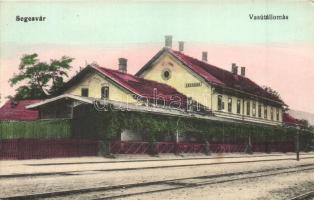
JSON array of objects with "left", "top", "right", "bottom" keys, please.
[{"left": 0, "top": 120, "right": 71, "bottom": 139}]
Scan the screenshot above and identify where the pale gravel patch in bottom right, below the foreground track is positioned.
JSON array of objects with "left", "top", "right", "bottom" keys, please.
[{"left": 119, "top": 171, "right": 314, "bottom": 200}]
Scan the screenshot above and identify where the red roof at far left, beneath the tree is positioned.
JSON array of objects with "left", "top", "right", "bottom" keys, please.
[{"left": 0, "top": 100, "right": 41, "bottom": 121}]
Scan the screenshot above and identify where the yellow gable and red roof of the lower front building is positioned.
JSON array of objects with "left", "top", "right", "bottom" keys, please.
[{"left": 64, "top": 65, "right": 186, "bottom": 108}]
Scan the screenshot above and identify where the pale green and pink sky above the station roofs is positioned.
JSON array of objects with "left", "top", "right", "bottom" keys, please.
[{"left": 0, "top": 0, "right": 314, "bottom": 113}]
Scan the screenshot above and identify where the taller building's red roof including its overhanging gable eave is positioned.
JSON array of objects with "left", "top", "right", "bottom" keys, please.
[{"left": 136, "top": 48, "right": 284, "bottom": 105}]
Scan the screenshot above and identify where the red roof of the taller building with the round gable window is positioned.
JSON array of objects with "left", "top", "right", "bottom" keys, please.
[{"left": 136, "top": 48, "right": 283, "bottom": 104}]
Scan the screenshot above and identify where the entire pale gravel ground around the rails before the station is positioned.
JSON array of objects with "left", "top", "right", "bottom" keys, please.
[{"left": 0, "top": 154, "right": 314, "bottom": 199}]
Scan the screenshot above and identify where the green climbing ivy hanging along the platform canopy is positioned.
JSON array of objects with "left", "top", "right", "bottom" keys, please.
[{"left": 74, "top": 105, "right": 313, "bottom": 151}]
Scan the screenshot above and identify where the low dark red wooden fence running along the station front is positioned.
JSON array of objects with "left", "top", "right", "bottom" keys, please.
[{"left": 0, "top": 139, "right": 294, "bottom": 159}]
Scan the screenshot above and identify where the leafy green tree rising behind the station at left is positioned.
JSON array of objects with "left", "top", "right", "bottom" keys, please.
[{"left": 9, "top": 53, "right": 73, "bottom": 100}]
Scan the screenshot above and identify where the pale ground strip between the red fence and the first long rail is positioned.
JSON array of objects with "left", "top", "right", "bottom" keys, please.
[{"left": 0, "top": 154, "right": 314, "bottom": 176}]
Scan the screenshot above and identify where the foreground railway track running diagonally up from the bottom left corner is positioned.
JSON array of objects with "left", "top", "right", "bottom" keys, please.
[{"left": 5, "top": 164, "right": 314, "bottom": 200}]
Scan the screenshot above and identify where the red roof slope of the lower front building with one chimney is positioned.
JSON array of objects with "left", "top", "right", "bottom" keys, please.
[{"left": 92, "top": 66, "right": 187, "bottom": 108}]
